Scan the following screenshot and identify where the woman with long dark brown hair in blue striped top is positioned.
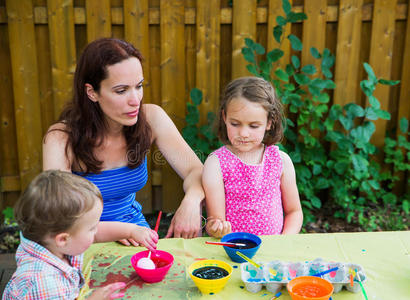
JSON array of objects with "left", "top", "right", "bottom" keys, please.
[{"left": 43, "top": 38, "right": 204, "bottom": 245}]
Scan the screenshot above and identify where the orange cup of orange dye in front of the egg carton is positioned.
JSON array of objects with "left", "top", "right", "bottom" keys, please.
[{"left": 286, "top": 276, "right": 333, "bottom": 300}]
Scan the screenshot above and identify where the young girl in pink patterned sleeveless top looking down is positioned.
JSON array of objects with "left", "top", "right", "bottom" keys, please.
[{"left": 202, "top": 77, "right": 303, "bottom": 238}]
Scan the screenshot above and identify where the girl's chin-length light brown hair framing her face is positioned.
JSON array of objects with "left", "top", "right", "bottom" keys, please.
[{"left": 217, "top": 77, "right": 283, "bottom": 146}]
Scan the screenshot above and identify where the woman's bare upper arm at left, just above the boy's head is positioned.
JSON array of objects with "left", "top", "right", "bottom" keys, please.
[{"left": 43, "top": 123, "right": 72, "bottom": 172}]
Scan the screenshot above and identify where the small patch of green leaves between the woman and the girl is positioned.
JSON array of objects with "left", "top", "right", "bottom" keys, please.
[{"left": 182, "top": 88, "right": 222, "bottom": 162}]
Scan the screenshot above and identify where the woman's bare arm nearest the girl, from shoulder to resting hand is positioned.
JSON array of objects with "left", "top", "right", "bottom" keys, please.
[{"left": 144, "top": 104, "right": 205, "bottom": 238}]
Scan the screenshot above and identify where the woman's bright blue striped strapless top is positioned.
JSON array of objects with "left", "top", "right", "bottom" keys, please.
[{"left": 73, "top": 157, "right": 150, "bottom": 227}]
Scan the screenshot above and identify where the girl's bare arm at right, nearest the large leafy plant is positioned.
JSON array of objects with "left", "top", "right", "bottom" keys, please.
[{"left": 280, "top": 151, "right": 303, "bottom": 234}]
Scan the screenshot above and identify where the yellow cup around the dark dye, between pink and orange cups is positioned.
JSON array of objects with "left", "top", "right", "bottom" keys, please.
[{"left": 188, "top": 259, "right": 232, "bottom": 294}]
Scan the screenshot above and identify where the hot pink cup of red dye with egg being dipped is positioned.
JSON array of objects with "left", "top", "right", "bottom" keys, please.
[{"left": 131, "top": 250, "right": 174, "bottom": 283}]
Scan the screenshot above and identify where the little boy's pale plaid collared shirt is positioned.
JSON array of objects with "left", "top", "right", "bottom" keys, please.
[{"left": 2, "top": 233, "right": 84, "bottom": 300}]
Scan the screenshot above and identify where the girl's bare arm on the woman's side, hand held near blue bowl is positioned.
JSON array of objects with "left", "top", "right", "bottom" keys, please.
[{"left": 202, "top": 155, "right": 231, "bottom": 238}]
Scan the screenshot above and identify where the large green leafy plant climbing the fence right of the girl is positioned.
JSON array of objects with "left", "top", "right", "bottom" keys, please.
[{"left": 242, "top": 0, "right": 409, "bottom": 230}]
